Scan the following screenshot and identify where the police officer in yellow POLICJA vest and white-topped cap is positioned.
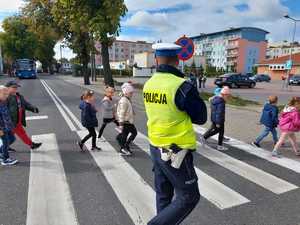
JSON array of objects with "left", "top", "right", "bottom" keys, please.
[{"left": 143, "top": 43, "right": 207, "bottom": 225}]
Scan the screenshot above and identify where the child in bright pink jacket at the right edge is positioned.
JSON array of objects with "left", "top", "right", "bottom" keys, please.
[{"left": 272, "top": 97, "right": 300, "bottom": 157}]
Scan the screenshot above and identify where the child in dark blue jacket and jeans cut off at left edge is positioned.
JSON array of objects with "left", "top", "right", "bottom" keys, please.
[{"left": 0, "top": 85, "right": 18, "bottom": 166}]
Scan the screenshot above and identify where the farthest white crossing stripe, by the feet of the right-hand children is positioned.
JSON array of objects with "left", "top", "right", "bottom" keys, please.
[{"left": 194, "top": 126, "right": 300, "bottom": 173}]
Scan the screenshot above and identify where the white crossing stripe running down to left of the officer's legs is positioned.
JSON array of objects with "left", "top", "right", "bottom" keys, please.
[{"left": 77, "top": 131, "right": 156, "bottom": 225}]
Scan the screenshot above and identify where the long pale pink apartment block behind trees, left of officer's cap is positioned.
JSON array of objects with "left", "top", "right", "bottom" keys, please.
[{"left": 95, "top": 40, "right": 152, "bottom": 65}]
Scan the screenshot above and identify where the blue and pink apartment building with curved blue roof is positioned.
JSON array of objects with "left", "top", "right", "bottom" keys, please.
[{"left": 192, "top": 27, "right": 269, "bottom": 73}]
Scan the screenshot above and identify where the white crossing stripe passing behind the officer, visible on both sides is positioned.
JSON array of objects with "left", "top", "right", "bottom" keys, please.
[{"left": 134, "top": 132, "right": 250, "bottom": 209}]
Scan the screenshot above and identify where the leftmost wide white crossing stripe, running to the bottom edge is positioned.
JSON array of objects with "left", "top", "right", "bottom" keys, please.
[{"left": 26, "top": 134, "right": 78, "bottom": 225}]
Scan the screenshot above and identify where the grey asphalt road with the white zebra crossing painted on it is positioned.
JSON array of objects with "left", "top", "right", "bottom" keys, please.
[{"left": 0, "top": 76, "right": 300, "bottom": 225}]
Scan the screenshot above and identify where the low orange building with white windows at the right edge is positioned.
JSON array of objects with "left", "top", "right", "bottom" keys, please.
[{"left": 257, "top": 53, "right": 300, "bottom": 80}]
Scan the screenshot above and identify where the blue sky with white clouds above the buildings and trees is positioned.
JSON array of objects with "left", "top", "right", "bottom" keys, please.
[{"left": 0, "top": 0, "right": 300, "bottom": 57}]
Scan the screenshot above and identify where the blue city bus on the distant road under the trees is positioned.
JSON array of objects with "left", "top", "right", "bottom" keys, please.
[{"left": 15, "top": 59, "right": 37, "bottom": 79}]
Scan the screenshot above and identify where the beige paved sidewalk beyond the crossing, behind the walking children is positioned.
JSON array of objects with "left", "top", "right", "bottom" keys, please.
[{"left": 57, "top": 76, "right": 300, "bottom": 161}]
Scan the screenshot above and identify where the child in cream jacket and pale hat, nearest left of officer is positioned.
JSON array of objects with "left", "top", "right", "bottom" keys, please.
[{"left": 117, "top": 83, "right": 137, "bottom": 156}]
